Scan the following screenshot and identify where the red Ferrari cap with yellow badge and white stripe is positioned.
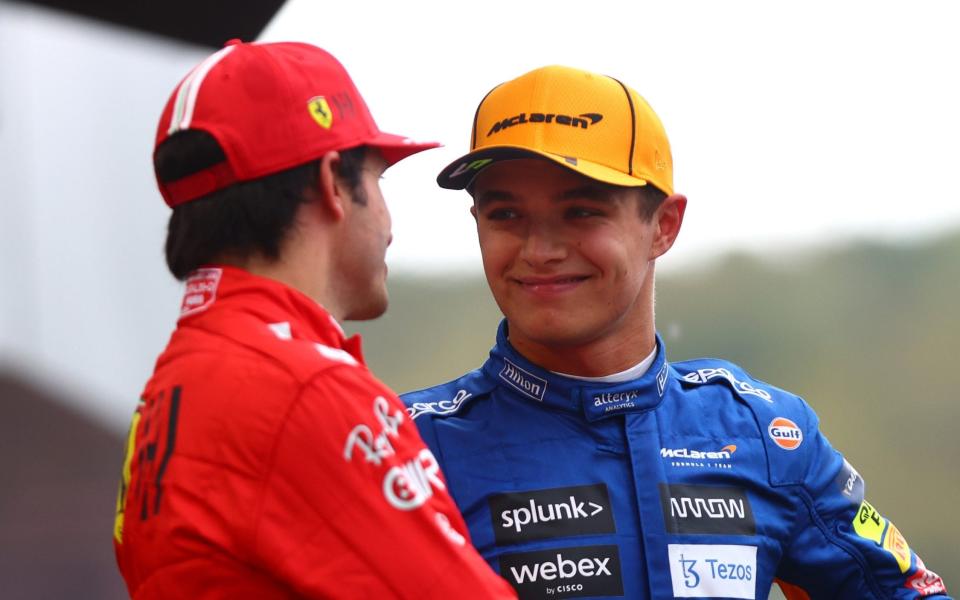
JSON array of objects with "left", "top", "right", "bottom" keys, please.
[{"left": 154, "top": 40, "right": 439, "bottom": 207}]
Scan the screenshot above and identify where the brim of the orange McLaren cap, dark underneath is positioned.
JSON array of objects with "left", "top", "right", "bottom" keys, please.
[{"left": 437, "top": 146, "right": 647, "bottom": 190}]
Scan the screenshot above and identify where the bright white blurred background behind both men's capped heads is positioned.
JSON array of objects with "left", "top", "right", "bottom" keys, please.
[{"left": 0, "top": 0, "right": 960, "bottom": 430}]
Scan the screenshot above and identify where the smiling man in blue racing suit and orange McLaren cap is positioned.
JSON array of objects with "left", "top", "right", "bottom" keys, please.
[{"left": 404, "top": 67, "right": 946, "bottom": 599}]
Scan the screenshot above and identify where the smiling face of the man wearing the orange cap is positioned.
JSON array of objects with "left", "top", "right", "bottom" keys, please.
[{"left": 473, "top": 159, "right": 686, "bottom": 374}]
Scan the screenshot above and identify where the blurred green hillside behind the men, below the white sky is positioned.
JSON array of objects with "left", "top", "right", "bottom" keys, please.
[{"left": 350, "top": 234, "right": 960, "bottom": 593}]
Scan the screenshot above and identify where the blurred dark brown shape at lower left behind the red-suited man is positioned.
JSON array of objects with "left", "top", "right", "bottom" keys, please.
[{"left": 0, "top": 367, "right": 132, "bottom": 600}]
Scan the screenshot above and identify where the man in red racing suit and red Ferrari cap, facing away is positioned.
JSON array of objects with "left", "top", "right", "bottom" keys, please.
[{"left": 114, "top": 43, "right": 515, "bottom": 600}]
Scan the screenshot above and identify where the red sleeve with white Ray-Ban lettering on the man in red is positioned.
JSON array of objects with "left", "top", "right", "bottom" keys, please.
[{"left": 255, "top": 366, "right": 515, "bottom": 598}]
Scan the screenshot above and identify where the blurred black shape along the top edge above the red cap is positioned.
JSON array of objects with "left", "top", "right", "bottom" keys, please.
[{"left": 6, "top": 0, "right": 284, "bottom": 48}]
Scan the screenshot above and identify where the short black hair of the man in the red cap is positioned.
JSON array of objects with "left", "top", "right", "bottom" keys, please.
[{"left": 154, "top": 130, "right": 366, "bottom": 280}]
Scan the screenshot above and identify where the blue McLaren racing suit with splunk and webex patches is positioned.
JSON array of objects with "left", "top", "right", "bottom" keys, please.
[{"left": 403, "top": 321, "right": 946, "bottom": 599}]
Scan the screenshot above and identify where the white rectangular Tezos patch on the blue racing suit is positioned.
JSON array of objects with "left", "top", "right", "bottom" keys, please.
[{"left": 667, "top": 544, "right": 757, "bottom": 600}]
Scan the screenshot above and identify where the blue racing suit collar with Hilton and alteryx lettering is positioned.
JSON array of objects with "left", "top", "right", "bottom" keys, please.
[{"left": 483, "top": 319, "right": 671, "bottom": 421}]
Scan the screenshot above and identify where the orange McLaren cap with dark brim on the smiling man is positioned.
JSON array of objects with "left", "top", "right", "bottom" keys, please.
[{"left": 437, "top": 66, "right": 673, "bottom": 194}]
